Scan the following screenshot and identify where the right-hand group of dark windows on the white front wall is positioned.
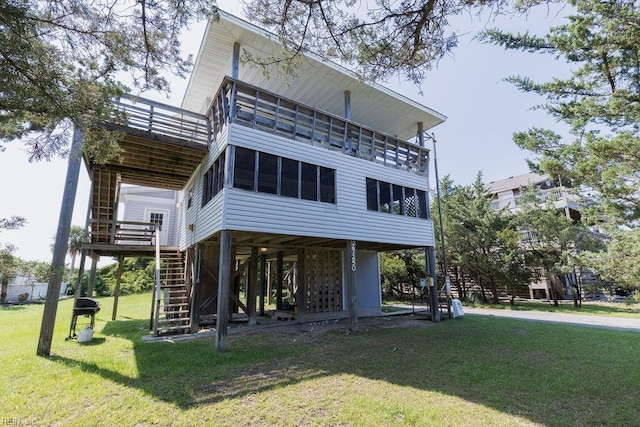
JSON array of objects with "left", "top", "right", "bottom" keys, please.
[{"left": 366, "top": 178, "right": 428, "bottom": 219}]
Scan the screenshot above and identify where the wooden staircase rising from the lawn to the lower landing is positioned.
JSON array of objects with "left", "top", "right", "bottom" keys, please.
[{"left": 153, "top": 251, "right": 191, "bottom": 336}]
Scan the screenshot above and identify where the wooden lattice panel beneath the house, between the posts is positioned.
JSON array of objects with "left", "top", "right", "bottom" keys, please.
[{"left": 305, "top": 250, "right": 342, "bottom": 313}]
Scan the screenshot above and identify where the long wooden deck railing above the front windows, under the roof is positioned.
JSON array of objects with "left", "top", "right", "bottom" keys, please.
[{"left": 206, "top": 77, "right": 429, "bottom": 175}]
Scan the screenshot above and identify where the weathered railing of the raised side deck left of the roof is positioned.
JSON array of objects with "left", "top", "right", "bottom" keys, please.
[{"left": 114, "top": 94, "right": 211, "bottom": 146}]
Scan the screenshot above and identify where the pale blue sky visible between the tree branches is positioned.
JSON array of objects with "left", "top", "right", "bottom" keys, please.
[{"left": 0, "top": 0, "right": 568, "bottom": 262}]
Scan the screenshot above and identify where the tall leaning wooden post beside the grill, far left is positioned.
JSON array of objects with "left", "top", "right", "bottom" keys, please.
[{"left": 36, "top": 128, "right": 84, "bottom": 356}]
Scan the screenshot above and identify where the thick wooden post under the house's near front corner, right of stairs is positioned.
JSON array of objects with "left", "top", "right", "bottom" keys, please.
[{"left": 215, "top": 230, "right": 231, "bottom": 351}]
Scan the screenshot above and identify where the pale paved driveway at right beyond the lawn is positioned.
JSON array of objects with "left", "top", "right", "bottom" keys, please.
[{"left": 463, "top": 306, "right": 640, "bottom": 332}]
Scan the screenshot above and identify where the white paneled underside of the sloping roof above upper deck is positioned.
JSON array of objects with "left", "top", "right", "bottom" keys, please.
[{"left": 182, "top": 11, "right": 446, "bottom": 140}]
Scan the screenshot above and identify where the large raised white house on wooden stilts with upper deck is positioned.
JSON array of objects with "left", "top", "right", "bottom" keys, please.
[{"left": 74, "top": 12, "right": 446, "bottom": 348}]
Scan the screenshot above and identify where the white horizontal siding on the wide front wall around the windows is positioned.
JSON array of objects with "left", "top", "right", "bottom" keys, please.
[{"left": 224, "top": 125, "right": 434, "bottom": 246}]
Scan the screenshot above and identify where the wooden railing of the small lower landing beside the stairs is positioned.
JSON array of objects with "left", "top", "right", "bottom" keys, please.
[{"left": 88, "top": 219, "right": 158, "bottom": 245}]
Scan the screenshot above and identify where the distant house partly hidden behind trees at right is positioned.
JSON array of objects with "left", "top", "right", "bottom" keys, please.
[{"left": 485, "top": 172, "right": 597, "bottom": 299}]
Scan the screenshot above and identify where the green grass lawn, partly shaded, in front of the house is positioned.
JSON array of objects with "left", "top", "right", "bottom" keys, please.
[{"left": 0, "top": 294, "right": 640, "bottom": 426}]
